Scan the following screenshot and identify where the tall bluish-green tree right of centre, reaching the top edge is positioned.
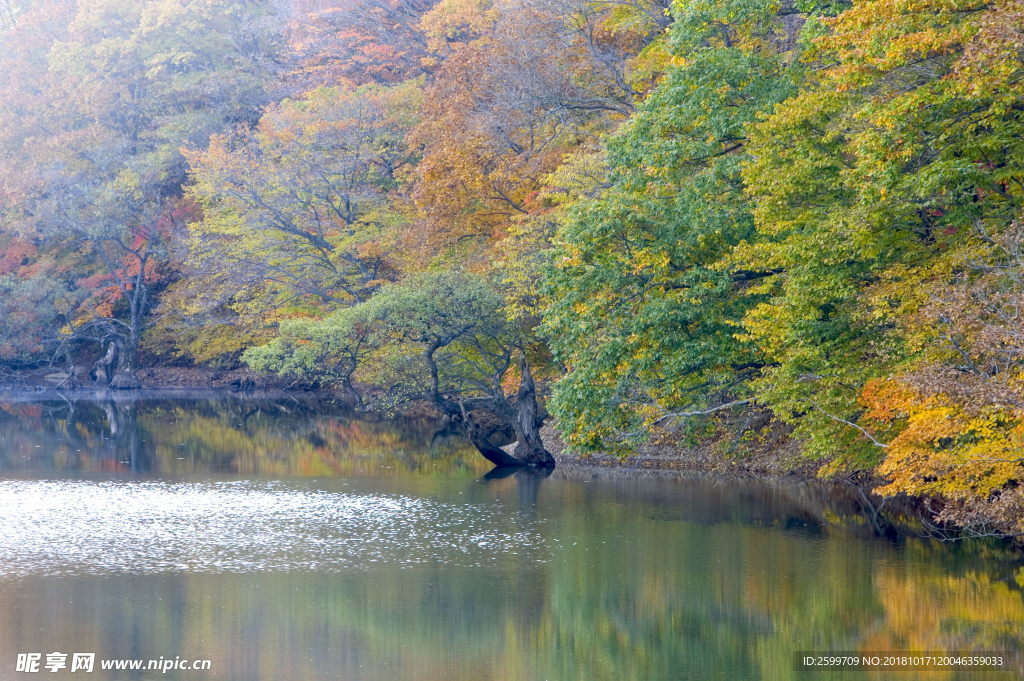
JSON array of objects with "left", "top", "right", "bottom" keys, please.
[{"left": 544, "top": 1, "right": 800, "bottom": 449}]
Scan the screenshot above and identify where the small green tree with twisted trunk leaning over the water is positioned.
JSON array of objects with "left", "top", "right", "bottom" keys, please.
[{"left": 243, "top": 271, "right": 554, "bottom": 467}]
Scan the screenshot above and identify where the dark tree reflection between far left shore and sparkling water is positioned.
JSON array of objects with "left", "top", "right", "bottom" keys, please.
[{"left": 0, "top": 393, "right": 488, "bottom": 477}]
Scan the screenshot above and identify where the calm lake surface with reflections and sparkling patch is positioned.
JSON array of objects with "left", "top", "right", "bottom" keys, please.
[{"left": 0, "top": 397, "right": 1024, "bottom": 681}]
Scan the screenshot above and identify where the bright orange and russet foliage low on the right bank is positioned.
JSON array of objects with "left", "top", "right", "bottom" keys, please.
[{"left": 861, "top": 224, "right": 1024, "bottom": 504}]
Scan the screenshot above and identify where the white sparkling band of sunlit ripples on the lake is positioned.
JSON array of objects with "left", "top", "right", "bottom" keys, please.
[{"left": 0, "top": 480, "right": 546, "bottom": 577}]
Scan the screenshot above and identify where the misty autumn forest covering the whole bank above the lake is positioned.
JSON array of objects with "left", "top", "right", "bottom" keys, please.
[{"left": 0, "top": 0, "right": 1024, "bottom": 536}]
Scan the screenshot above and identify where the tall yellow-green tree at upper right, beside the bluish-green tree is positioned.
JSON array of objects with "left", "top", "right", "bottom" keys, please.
[{"left": 733, "top": 0, "right": 1024, "bottom": 466}]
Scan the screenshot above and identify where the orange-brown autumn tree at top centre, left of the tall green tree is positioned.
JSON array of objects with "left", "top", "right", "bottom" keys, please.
[{"left": 411, "top": 0, "right": 648, "bottom": 260}]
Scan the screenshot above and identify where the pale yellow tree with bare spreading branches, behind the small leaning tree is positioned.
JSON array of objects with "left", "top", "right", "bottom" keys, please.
[{"left": 165, "top": 81, "right": 420, "bottom": 358}]
